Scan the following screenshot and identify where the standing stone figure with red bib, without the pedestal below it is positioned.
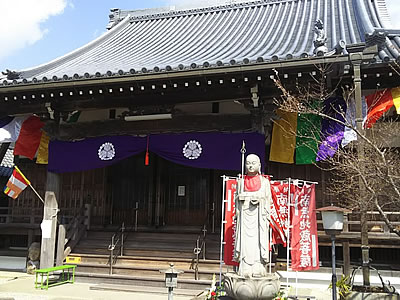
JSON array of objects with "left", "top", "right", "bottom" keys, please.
[{"left": 234, "top": 154, "right": 271, "bottom": 277}]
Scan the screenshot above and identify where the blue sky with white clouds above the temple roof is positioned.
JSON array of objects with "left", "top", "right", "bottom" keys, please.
[{"left": 0, "top": 0, "right": 400, "bottom": 71}]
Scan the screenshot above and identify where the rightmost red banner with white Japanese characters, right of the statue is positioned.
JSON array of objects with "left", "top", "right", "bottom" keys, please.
[{"left": 291, "top": 184, "right": 319, "bottom": 271}]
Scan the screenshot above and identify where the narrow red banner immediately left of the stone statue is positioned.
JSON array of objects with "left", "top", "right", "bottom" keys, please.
[{"left": 224, "top": 179, "right": 239, "bottom": 266}]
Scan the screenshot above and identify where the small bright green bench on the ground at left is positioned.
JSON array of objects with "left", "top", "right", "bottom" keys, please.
[{"left": 35, "top": 265, "right": 76, "bottom": 290}]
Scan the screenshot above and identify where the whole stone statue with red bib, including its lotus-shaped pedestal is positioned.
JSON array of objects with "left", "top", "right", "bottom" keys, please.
[{"left": 224, "top": 154, "right": 280, "bottom": 300}]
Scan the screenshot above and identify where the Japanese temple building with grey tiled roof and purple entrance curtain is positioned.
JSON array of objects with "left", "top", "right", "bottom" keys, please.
[{"left": 0, "top": 0, "right": 400, "bottom": 290}]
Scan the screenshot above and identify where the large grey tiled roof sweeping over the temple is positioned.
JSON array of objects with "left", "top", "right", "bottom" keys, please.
[{"left": 0, "top": 0, "right": 400, "bottom": 85}]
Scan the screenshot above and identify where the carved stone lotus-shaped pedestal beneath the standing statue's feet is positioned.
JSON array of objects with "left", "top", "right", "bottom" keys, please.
[{"left": 224, "top": 273, "right": 280, "bottom": 300}]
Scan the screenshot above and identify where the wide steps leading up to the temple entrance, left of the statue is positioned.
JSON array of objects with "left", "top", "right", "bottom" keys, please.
[{"left": 69, "top": 230, "right": 228, "bottom": 295}]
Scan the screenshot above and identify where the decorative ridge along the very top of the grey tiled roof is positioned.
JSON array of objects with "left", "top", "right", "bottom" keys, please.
[{"left": 125, "top": 0, "right": 290, "bottom": 21}]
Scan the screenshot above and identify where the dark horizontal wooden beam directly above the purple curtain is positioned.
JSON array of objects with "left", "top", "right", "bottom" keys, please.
[{"left": 45, "top": 114, "right": 252, "bottom": 141}]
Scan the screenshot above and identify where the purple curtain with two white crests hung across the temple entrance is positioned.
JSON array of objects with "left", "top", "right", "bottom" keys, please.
[{"left": 48, "top": 133, "right": 265, "bottom": 173}]
